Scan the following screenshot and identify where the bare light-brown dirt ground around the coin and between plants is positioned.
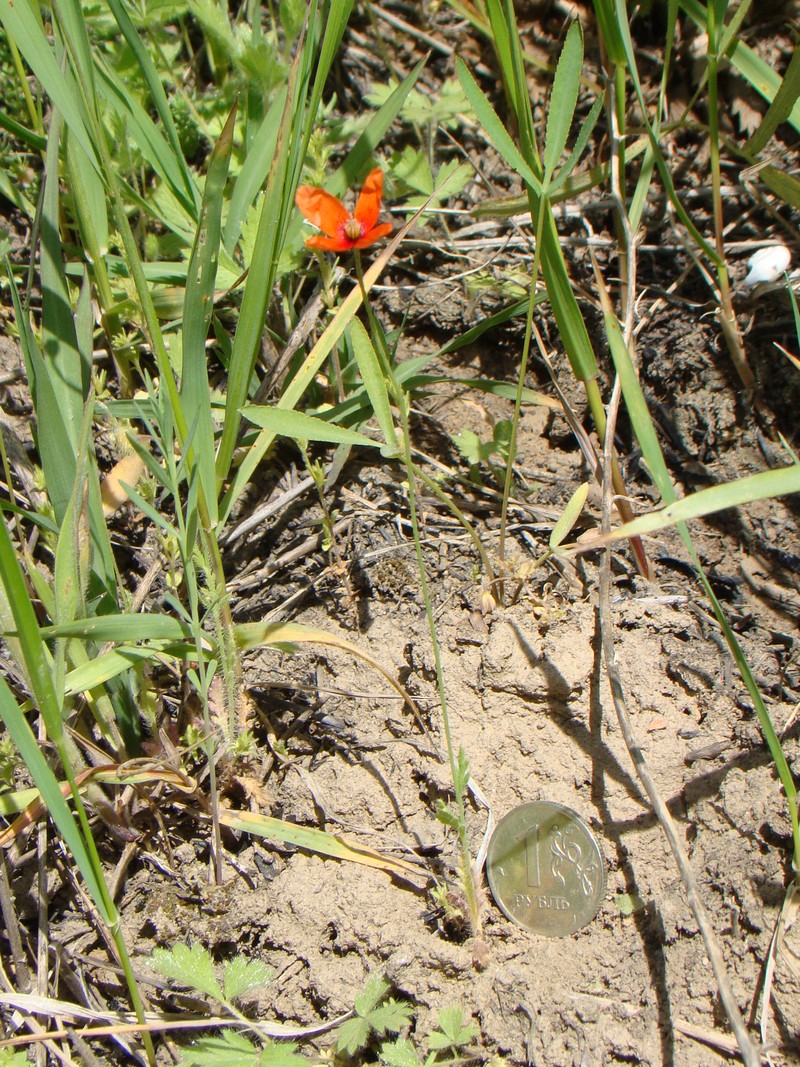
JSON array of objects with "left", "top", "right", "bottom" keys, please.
[{"left": 4, "top": 2, "right": 800, "bottom": 1067}]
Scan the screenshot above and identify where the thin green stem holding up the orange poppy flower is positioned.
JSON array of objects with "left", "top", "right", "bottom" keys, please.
[{"left": 355, "top": 249, "right": 481, "bottom": 937}]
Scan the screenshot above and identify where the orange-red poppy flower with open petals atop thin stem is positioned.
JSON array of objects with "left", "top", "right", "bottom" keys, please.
[{"left": 294, "top": 166, "right": 393, "bottom": 252}]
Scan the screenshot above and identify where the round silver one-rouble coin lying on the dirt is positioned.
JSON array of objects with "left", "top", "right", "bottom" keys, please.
[{"left": 486, "top": 800, "right": 606, "bottom": 937}]
